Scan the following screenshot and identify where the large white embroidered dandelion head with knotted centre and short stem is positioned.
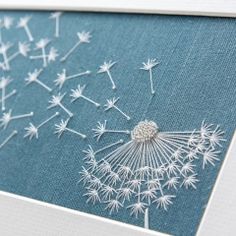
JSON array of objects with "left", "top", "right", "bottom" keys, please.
[{"left": 80, "top": 120, "right": 224, "bottom": 228}]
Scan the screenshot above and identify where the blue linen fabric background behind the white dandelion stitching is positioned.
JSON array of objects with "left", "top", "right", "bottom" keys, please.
[{"left": 0, "top": 11, "right": 236, "bottom": 236}]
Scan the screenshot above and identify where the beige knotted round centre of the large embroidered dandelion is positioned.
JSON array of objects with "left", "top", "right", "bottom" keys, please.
[{"left": 131, "top": 120, "right": 158, "bottom": 142}]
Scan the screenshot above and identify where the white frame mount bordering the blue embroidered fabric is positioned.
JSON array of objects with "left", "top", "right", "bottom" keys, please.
[{"left": 0, "top": 0, "right": 236, "bottom": 236}]
